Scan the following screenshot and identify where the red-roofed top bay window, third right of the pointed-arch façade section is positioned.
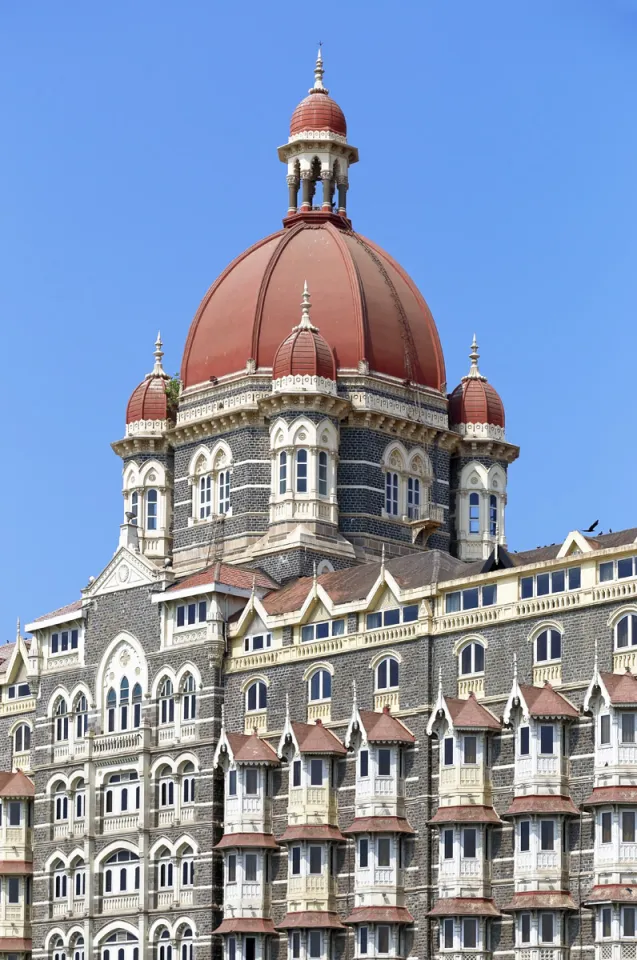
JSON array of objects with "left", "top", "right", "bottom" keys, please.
[{"left": 345, "top": 699, "right": 416, "bottom": 817}]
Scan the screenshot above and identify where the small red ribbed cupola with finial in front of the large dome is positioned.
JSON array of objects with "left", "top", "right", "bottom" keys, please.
[{"left": 272, "top": 281, "right": 336, "bottom": 392}]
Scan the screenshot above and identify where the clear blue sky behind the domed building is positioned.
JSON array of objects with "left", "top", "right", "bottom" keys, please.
[{"left": 0, "top": 0, "right": 637, "bottom": 641}]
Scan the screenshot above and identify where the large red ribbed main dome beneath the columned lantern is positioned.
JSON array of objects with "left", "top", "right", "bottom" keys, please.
[{"left": 181, "top": 214, "right": 445, "bottom": 390}]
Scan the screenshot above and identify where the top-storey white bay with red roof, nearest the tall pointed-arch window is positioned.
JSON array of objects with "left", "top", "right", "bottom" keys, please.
[{"left": 213, "top": 724, "right": 279, "bottom": 836}]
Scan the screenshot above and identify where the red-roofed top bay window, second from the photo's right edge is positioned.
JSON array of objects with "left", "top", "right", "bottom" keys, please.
[{"left": 504, "top": 675, "right": 579, "bottom": 796}]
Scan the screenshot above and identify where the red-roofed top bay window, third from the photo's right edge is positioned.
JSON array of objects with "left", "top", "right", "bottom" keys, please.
[{"left": 427, "top": 684, "right": 501, "bottom": 807}]
